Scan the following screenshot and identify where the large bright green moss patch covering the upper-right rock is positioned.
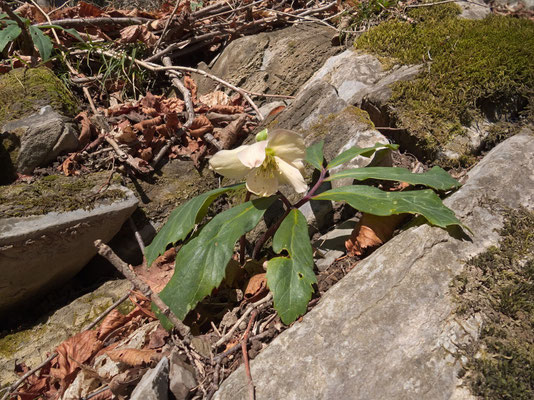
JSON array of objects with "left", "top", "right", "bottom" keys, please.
[{"left": 355, "top": 4, "right": 534, "bottom": 159}]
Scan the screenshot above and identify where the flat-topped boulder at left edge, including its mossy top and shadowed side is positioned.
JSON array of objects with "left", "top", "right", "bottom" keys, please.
[{"left": 0, "top": 173, "right": 137, "bottom": 314}]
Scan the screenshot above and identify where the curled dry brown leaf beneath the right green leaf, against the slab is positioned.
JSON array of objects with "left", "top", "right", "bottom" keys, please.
[{"left": 345, "top": 214, "right": 406, "bottom": 256}]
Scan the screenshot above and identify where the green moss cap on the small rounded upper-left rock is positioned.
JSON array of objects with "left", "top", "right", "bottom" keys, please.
[{"left": 0, "top": 67, "right": 79, "bottom": 124}]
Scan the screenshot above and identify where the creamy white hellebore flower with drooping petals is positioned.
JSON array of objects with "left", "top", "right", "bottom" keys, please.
[{"left": 210, "top": 129, "right": 307, "bottom": 196}]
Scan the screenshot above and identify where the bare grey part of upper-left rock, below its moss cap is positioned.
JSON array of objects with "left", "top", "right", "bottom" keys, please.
[{"left": 1, "top": 106, "right": 79, "bottom": 175}]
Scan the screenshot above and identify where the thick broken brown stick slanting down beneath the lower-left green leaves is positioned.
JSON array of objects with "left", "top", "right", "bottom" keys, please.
[{"left": 95, "top": 240, "right": 190, "bottom": 338}]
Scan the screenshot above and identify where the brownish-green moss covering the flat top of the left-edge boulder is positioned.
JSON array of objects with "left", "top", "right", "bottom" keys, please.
[{"left": 0, "top": 172, "right": 126, "bottom": 217}]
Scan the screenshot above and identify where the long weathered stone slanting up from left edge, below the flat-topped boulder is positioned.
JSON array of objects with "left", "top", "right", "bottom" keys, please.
[{"left": 0, "top": 279, "right": 132, "bottom": 384}]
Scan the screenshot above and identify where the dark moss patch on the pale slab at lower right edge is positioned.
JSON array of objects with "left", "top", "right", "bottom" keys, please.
[{"left": 454, "top": 210, "right": 534, "bottom": 400}]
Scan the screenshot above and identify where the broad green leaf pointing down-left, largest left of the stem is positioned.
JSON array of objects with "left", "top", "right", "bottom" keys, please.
[{"left": 159, "top": 196, "right": 276, "bottom": 319}]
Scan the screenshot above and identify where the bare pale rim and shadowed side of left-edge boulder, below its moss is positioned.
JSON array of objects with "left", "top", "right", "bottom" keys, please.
[{"left": 0, "top": 187, "right": 137, "bottom": 314}]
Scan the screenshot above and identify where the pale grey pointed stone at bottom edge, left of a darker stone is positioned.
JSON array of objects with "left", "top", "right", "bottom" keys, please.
[{"left": 130, "top": 357, "right": 169, "bottom": 400}]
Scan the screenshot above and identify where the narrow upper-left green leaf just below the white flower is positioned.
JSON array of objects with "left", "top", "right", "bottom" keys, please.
[{"left": 145, "top": 183, "right": 245, "bottom": 267}]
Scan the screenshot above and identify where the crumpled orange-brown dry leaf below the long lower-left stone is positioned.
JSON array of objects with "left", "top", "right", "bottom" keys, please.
[{"left": 50, "top": 330, "right": 103, "bottom": 382}]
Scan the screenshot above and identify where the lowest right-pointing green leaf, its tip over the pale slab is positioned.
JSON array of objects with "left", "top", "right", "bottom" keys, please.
[{"left": 312, "top": 185, "right": 462, "bottom": 228}]
